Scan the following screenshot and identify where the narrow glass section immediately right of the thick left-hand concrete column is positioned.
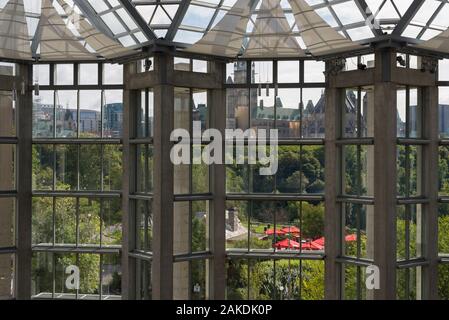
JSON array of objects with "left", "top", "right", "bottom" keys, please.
[{"left": 173, "top": 87, "right": 212, "bottom": 300}]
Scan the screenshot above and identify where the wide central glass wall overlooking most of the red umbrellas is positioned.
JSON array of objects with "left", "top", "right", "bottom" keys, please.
[{"left": 226, "top": 60, "right": 325, "bottom": 300}]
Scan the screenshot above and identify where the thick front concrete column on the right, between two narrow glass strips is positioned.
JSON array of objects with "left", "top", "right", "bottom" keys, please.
[{"left": 374, "top": 50, "right": 397, "bottom": 300}]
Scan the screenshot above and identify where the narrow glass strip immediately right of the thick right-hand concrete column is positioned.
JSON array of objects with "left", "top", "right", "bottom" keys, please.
[{"left": 396, "top": 87, "right": 425, "bottom": 300}]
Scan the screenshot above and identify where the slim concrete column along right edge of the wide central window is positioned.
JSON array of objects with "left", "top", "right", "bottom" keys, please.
[{"left": 324, "top": 69, "right": 342, "bottom": 300}]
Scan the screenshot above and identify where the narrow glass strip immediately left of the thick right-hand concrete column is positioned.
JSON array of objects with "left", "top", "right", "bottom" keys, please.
[{"left": 337, "top": 86, "right": 374, "bottom": 300}]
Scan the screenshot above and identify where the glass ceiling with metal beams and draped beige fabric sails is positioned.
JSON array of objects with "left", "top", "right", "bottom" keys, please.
[{"left": 0, "top": 0, "right": 449, "bottom": 60}]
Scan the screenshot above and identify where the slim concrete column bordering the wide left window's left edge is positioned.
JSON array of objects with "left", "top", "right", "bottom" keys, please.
[{"left": 16, "top": 65, "right": 33, "bottom": 300}]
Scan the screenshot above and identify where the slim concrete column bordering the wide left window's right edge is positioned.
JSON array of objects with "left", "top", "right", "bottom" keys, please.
[{"left": 122, "top": 62, "right": 140, "bottom": 300}]
